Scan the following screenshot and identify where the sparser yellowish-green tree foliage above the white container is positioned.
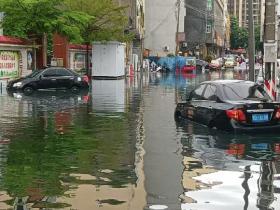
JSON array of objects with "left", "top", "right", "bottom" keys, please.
[{"left": 65, "top": 0, "right": 133, "bottom": 42}]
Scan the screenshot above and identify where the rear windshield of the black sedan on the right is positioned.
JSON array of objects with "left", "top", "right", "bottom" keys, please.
[{"left": 223, "top": 82, "right": 271, "bottom": 101}]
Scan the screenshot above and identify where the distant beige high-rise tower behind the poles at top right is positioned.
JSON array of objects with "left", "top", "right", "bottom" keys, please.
[{"left": 228, "top": 0, "right": 265, "bottom": 27}]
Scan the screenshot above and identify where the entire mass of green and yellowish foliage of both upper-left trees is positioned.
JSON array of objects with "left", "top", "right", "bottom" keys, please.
[{"left": 0, "top": 0, "right": 131, "bottom": 43}]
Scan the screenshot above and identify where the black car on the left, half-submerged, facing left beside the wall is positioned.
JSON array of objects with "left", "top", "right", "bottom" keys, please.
[{"left": 7, "top": 67, "right": 89, "bottom": 94}]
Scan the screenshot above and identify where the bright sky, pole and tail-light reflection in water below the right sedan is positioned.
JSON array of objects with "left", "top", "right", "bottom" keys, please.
[{"left": 178, "top": 122, "right": 280, "bottom": 209}]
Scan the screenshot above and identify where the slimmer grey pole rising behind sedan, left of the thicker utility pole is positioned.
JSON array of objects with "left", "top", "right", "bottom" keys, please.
[{"left": 248, "top": 0, "right": 255, "bottom": 82}]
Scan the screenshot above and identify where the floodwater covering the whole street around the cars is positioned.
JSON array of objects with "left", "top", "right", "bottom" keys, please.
[{"left": 0, "top": 71, "right": 280, "bottom": 210}]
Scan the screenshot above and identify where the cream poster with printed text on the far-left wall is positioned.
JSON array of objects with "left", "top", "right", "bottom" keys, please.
[{"left": 0, "top": 51, "right": 19, "bottom": 79}]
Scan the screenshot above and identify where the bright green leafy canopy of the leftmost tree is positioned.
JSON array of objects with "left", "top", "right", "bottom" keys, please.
[{"left": 0, "top": 0, "right": 92, "bottom": 41}]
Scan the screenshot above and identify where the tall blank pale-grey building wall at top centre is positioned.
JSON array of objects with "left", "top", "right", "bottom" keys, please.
[{"left": 144, "top": 0, "right": 186, "bottom": 56}]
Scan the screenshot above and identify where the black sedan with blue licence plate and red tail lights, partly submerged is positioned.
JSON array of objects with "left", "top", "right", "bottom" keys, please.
[{"left": 175, "top": 80, "right": 280, "bottom": 132}]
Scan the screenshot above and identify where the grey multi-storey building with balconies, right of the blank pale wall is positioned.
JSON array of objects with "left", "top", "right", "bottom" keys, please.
[{"left": 185, "top": 0, "right": 229, "bottom": 58}]
